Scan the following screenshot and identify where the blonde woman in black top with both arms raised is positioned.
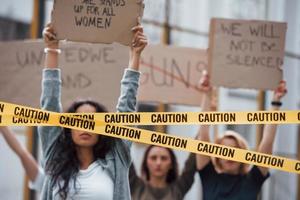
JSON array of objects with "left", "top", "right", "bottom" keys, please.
[{"left": 197, "top": 73, "right": 287, "bottom": 200}]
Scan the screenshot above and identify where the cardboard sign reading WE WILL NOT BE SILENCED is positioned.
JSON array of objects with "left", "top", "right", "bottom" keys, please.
[{"left": 208, "top": 19, "right": 287, "bottom": 90}]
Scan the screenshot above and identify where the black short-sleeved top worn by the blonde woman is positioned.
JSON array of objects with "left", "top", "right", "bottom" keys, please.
[{"left": 198, "top": 162, "right": 270, "bottom": 200}]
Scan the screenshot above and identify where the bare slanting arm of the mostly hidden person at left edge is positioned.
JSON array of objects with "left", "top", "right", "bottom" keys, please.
[{"left": 0, "top": 127, "right": 39, "bottom": 182}]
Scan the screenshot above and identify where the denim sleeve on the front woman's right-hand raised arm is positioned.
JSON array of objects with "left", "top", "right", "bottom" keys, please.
[{"left": 116, "top": 69, "right": 140, "bottom": 167}]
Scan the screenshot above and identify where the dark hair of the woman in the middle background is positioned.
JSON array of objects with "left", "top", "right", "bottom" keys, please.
[{"left": 141, "top": 145, "right": 178, "bottom": 183}]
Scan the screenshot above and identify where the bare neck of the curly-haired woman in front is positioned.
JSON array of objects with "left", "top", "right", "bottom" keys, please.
[{"left": 76, "top": 147, "right": 95, "bottom": 169}]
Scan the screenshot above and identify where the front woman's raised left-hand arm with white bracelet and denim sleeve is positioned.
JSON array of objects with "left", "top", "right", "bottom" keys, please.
[{"left": 38, "top": 24, "right": 62, "bottom": 160}]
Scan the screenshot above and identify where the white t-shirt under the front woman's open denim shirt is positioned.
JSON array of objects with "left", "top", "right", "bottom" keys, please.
[{"left": 52, "top": 161, "right": 114, "bottom": 200}]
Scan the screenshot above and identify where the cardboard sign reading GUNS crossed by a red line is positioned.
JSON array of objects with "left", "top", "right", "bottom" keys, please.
[{"left": 138, "top": 45, "right": 207, "bottom": 106}]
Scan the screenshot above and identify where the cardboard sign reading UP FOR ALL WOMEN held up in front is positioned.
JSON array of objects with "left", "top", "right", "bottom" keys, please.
[{"left": 52, "top": 0, "right": 144, "bottom": 46}]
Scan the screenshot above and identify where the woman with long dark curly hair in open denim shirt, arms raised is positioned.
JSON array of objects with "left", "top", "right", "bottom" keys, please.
[{"left": 38, "top": 21, "right": 147, "bottom": 200}]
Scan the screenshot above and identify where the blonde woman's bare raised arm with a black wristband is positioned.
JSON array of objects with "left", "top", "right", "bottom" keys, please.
[{"left": 258, "top": 81, "right": 287, "bottom": 175}]
